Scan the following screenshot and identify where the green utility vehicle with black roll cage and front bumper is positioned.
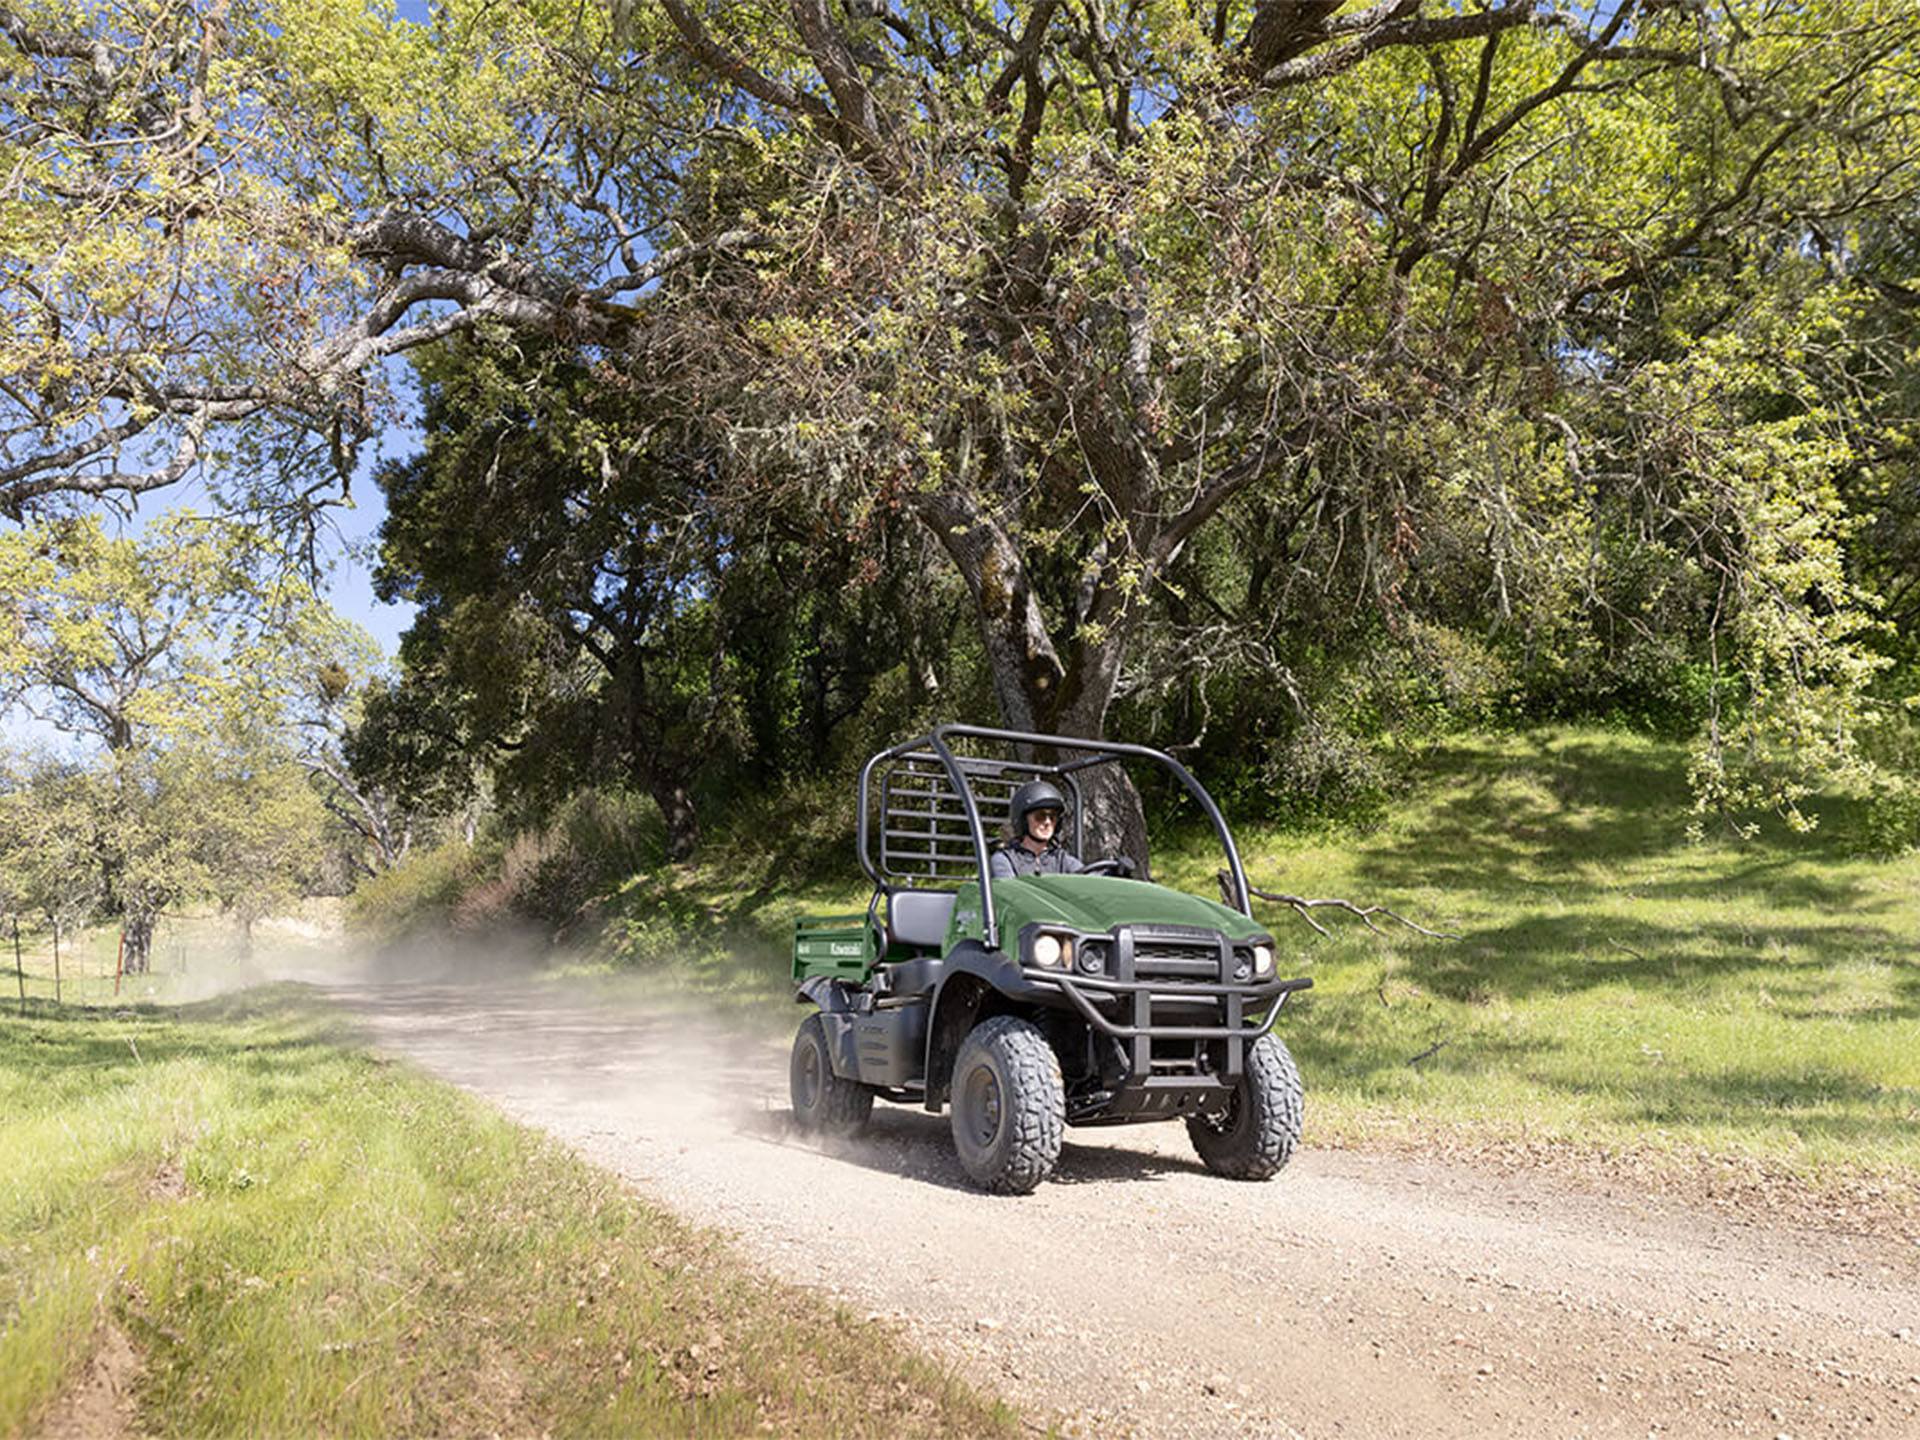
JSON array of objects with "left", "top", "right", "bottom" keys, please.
[{"left": 791, "top": 726, "right": 1313, "bottom": 1194}]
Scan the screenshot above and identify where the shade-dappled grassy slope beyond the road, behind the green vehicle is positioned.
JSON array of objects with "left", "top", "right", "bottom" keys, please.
[{"left": 583, "top": 730, "right": 1920, "bottom": 1194}]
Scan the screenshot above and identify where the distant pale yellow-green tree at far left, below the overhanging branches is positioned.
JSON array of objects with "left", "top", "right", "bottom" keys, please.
[{"left": 0, "top": 515, "right": 357, "bottom": 972}]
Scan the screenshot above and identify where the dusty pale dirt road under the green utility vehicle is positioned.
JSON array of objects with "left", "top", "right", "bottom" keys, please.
[{"left": 334, "top": 983, "right": 1920, "bottom": 1440}]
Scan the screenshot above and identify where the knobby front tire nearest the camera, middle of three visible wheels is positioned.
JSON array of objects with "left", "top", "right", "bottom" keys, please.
[{"left": 948, "top": 1016, "right": 1068, "bottom": 1194}]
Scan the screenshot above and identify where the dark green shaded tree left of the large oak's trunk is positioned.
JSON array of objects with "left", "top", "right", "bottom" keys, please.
[{"left": 364, "top": 346, "right": 960, "bottom": 856}]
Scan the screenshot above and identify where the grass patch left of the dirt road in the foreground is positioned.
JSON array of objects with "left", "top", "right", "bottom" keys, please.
[{"left": 0, "top": 987, "right": 1016, "bottom": 1436}]
